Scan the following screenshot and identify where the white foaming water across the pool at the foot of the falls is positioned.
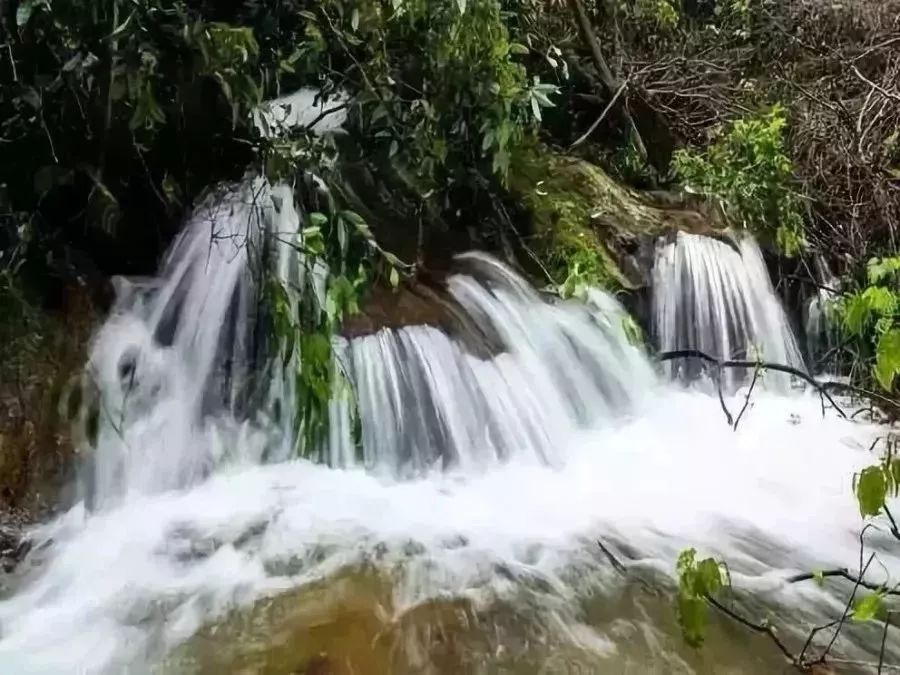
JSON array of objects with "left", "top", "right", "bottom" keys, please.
[{"left": 0, "top": 389, "right": 884, "bottom": 673}]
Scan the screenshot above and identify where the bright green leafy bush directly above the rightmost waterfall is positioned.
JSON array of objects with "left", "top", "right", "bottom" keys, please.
[{"left": 673, "top": 105, "right": 804, "bottom": 255}]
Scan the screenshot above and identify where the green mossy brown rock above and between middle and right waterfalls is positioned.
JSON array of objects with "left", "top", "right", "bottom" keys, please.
[{"left": 509, "top": 145, "right": 721, "bottom": 289}]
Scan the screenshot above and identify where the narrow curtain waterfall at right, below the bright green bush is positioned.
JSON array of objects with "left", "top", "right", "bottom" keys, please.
[{"left": 653, "top": 233, "right": 805, "bottom": 386}]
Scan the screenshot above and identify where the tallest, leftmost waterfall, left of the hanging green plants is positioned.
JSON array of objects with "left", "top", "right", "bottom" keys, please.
[{"left": 87, "top": 180, "right": 298, "bottom": 504}]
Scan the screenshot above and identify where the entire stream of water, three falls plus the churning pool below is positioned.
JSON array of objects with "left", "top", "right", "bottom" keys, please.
[{"left": 0, "top": 183, "right": 900, "bottom": 674}]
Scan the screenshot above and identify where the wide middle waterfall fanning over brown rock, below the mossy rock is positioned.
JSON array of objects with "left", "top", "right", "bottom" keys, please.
[{"left": 350, "top": 254, "right": 654, "bottom": 475}]
